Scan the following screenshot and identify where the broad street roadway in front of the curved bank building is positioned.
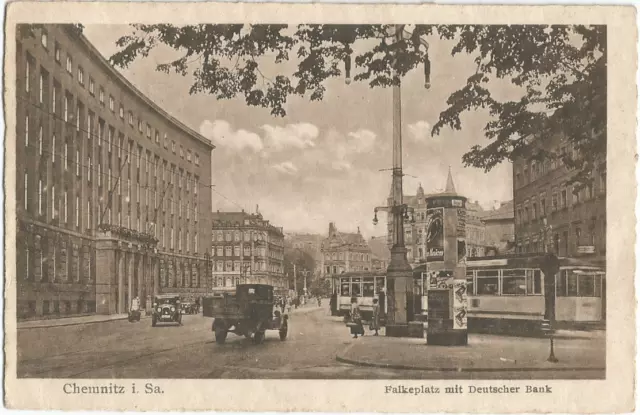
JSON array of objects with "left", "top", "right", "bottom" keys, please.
[{"left": 18, "top": 306, "right": 604, "bottom": 379}]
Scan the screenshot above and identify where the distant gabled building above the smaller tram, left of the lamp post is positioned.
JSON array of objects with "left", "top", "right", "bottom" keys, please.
[{"left": 320, "top": 222, "right": 372, "bottom": 277}]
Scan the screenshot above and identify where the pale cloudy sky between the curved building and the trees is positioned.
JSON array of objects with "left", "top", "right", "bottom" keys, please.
[{"left": 84, "top": 25, "right": 514, "bottom": 238}]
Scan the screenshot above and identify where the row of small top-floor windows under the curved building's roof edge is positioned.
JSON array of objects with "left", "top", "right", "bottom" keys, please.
[{"left": 25, "top": 29, "right": 200, "bottom": 166}]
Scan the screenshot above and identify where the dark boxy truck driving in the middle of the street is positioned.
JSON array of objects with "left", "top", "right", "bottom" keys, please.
[{"left": 202, "top": 284, "right": 289, "bottom": 344}]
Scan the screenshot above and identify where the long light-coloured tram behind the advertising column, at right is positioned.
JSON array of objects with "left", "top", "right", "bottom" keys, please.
[{"left": 414, "top": 255, "right": 606, "bottom": 333}]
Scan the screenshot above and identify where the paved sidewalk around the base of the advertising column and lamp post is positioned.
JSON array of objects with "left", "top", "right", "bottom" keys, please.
[{"left": 336, "top": 328, "right": 606, "bottom": 372}]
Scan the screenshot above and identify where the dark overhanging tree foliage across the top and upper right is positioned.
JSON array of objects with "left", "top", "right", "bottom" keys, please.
[{"left": 110, "top": 24, "right": 607, "bottom": 183}]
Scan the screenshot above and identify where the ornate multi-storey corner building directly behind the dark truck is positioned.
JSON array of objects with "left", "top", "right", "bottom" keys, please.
[{"left": 211, "top": 211, "right": 289, "bottom": 292}]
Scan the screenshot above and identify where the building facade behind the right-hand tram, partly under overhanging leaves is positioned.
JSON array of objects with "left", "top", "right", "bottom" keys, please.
[{"left": 513, "top": 136, "right": 607, "bottom": 264}]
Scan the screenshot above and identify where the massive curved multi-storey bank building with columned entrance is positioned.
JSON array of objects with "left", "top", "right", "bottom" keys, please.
[{"left": 15, "top": 25, "right": 214, "bottom": 319}]
